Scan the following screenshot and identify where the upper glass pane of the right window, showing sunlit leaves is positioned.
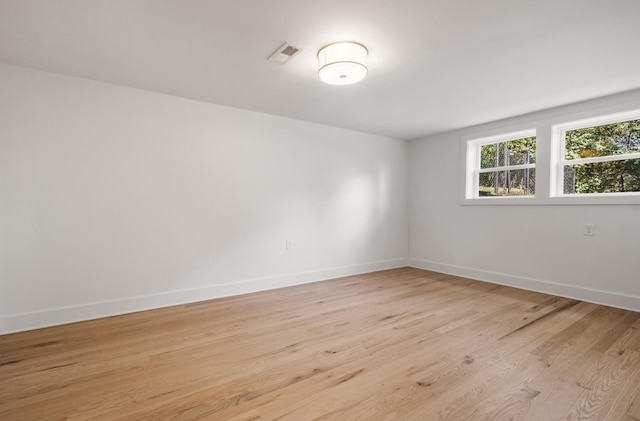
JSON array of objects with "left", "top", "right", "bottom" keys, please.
[{"left": 565, "top": 120, "right": 640, "bottom": 159}]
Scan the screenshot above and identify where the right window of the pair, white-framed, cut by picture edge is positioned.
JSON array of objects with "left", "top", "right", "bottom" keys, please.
[{"left": 551, "top": 111, "right": 640, "bottom": 197}]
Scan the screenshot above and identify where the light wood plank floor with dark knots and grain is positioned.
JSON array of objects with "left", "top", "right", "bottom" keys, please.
[{"left": 0, "top": 268, "right": 640, "bottom": 421}]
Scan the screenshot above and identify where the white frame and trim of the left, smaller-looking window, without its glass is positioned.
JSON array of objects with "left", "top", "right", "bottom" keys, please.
[{"left": 462, "top": 129, "right": 538, "bottom": 204}]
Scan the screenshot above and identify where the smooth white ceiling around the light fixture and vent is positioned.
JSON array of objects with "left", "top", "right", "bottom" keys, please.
[{"left": 0, "top": 0, "right": 640, "bottom": 139}]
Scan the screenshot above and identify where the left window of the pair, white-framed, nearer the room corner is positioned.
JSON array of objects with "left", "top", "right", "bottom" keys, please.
[{"left": 466, "top": 130, "right": 536, "bottom": 199}]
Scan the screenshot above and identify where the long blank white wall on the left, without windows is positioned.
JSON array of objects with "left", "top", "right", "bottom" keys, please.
[{"left": 0, "top": 65, "right": 408, "bottom": 333}]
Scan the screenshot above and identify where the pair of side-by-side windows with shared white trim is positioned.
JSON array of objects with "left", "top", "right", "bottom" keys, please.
[{"left": 460, "top": 106, "right": 640, "bottom": 206}]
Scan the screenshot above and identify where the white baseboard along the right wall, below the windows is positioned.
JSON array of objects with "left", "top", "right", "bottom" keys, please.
[{"left": 408, "top": 259, "right": 640, "bottom": 311}]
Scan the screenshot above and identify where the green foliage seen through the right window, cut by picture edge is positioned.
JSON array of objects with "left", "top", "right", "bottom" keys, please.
[{"left": 564, "top": 120, "right": 640, "bottom": 193}]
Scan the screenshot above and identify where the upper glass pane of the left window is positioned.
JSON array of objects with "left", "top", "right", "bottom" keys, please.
[{"left": 480, "top": 137, "right": 536, "bottom": 168}]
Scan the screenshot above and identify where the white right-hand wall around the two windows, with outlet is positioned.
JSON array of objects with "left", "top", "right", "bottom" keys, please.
[{"left": 409, "top": 91, "right": 640, "bottom": 310}]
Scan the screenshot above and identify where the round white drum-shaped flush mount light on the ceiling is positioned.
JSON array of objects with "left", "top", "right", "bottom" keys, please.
[{"left": 318, "top": 41, "right": 369, "bottom": 85}]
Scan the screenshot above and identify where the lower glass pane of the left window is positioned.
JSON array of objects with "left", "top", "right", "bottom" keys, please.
[{"left": 478, "top": 168, "right": 536, "bottom": 196}]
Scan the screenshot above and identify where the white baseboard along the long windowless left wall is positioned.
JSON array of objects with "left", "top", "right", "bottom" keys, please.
[{"left": 0, "top": 258, "right": 407, "bottom": 334}]
